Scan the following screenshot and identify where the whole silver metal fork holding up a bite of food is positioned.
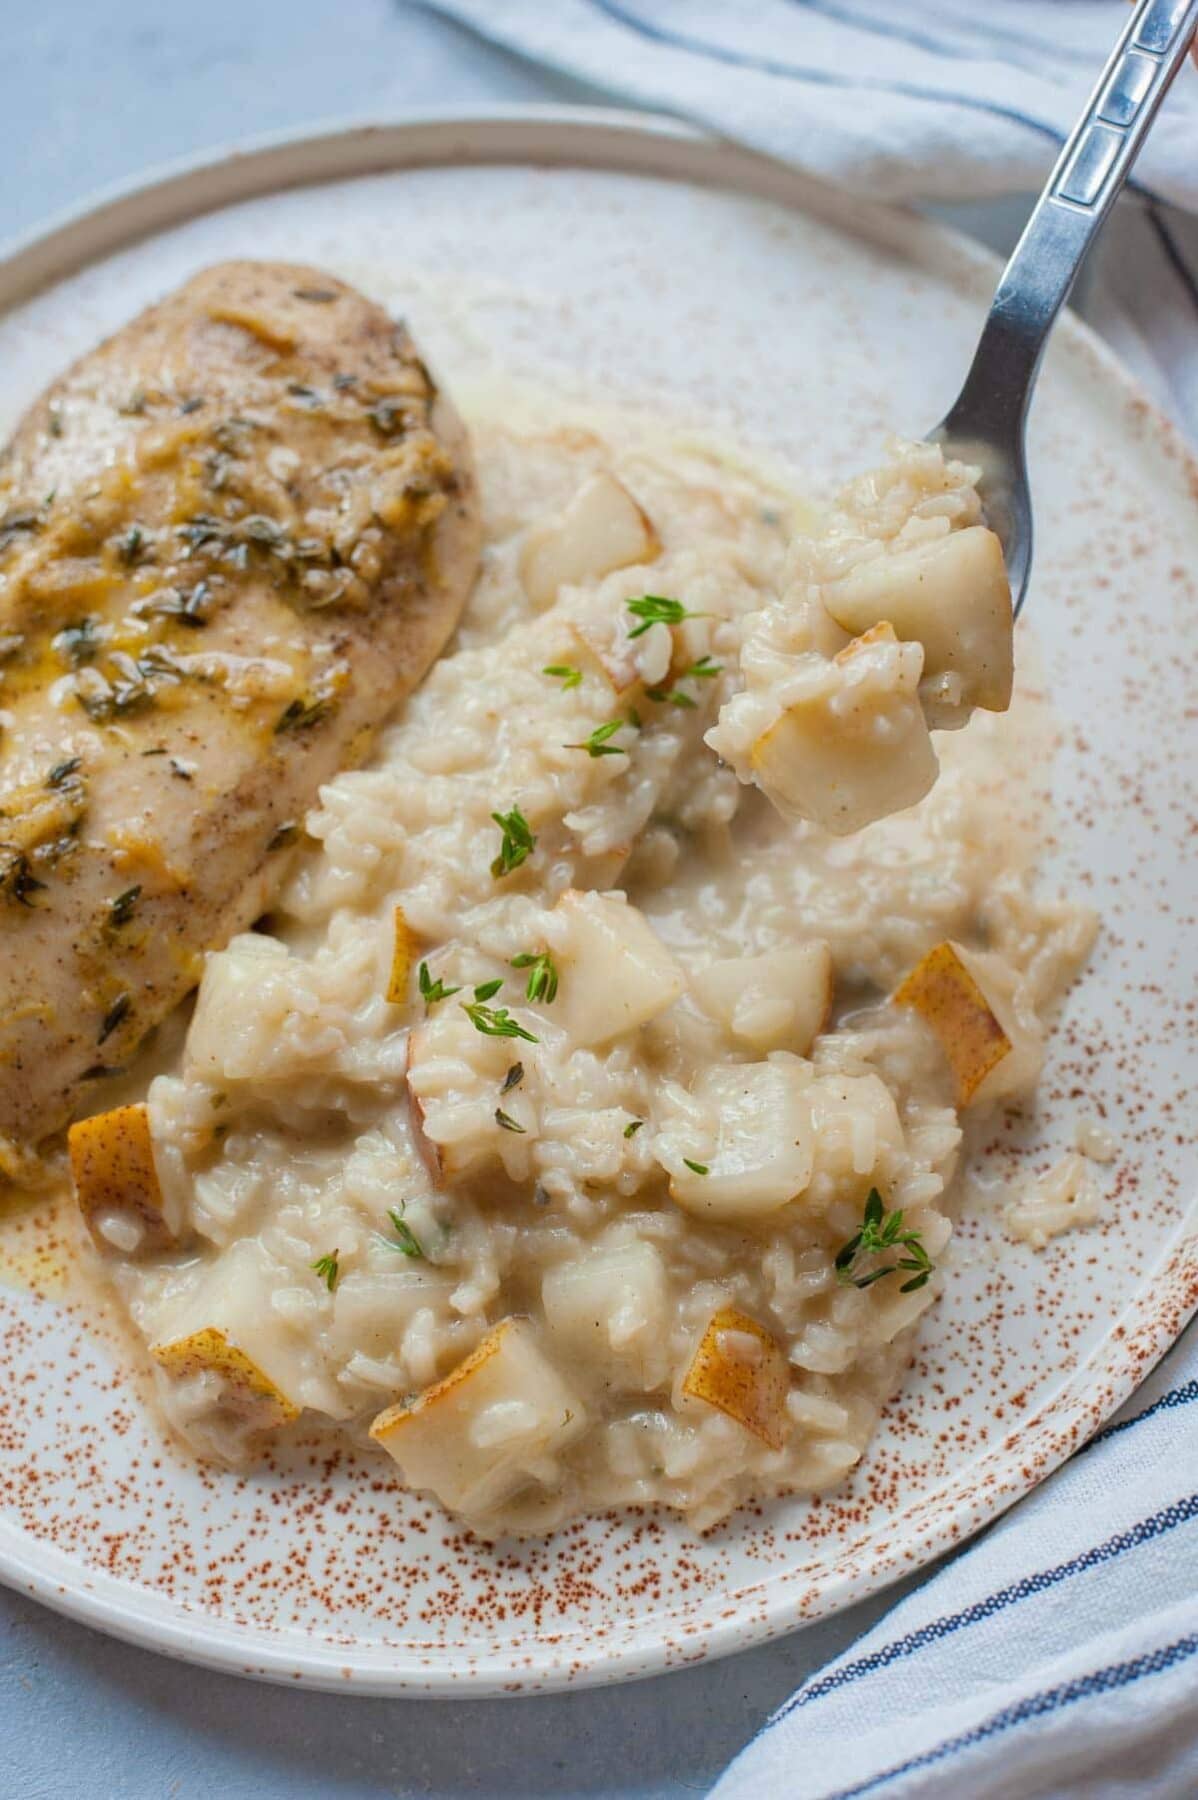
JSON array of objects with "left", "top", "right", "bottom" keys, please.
[{"left": 928, "top": 0, "right": 1198, "bottom": 616}]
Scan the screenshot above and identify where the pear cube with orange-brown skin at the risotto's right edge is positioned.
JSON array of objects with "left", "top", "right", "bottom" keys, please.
[{"left": 894, "top": 941, "right": 1043, "bottom": 1107}]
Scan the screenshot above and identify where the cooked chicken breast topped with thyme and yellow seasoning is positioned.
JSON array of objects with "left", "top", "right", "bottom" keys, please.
[{"left": 0, "top": 263, "right": 478, "bottom": 1181}]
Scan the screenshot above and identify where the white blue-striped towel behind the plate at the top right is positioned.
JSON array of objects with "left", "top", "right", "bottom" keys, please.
[{"left": 425, "top": 0, "right": 1198, "bottom": 441}]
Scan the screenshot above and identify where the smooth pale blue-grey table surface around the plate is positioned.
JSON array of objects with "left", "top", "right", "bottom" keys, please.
[{"left": 0, "top": 0, "right": 1036, "bottom": 1800}]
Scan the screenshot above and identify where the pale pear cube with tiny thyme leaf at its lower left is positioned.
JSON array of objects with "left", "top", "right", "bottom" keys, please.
[{"left": 653, "top": 1051, "right": 813, "bottom": 1222}]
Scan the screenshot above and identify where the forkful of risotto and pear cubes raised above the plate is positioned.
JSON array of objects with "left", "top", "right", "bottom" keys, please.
[{"left": 707, "top": 445, "right": 1015, "bottom": 835}]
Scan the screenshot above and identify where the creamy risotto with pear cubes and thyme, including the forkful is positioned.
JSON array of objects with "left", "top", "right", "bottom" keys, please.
[{"left": 72, "top": 405, "right": 1092, "bottom": 1534}]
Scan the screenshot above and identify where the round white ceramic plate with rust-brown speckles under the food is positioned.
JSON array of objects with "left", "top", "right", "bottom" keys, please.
[{"left": 0, "top": 112, "right": 1198, "bottom": 1694}]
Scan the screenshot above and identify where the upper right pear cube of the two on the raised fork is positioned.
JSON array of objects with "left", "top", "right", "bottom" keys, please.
[{"left": 824, "top": 526, "right": 1015, "bottom": 729}]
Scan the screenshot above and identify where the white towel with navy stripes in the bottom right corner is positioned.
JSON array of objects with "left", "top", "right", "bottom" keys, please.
[{"left": 712, "top": 1327, "right": 1198, "bottom": 1800}]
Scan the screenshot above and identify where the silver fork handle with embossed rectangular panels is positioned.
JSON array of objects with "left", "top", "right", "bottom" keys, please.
[{"left": 944, "top": 0, "right": 1198, "bottom": 441}]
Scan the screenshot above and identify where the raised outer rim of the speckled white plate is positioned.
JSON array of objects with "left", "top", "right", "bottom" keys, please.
[{"left": 0, "top": 106, "right": 1198, "bottom": 1697}]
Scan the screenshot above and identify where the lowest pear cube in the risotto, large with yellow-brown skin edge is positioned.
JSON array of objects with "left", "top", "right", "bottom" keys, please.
[{"left": 371, "top": 1319, "right": 586, "bottom": 1514}]
